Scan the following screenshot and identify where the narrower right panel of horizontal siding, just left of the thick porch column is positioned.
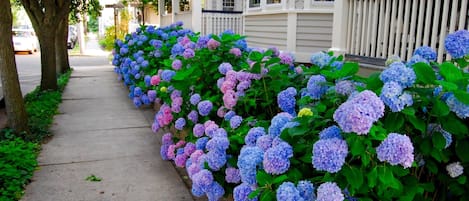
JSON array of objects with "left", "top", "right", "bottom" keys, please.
[{"left": 296, "top": 13, "right": 333, "bottom": 54}]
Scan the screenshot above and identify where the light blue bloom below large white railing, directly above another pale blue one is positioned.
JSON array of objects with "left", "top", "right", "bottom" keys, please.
[{"left": 379, "top": 62, "right": 417, "bottom": 88}]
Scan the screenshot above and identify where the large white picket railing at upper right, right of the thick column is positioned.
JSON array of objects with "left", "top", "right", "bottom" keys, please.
[{"left": 342, "top": 0, "right": 469, "bottom": 62}]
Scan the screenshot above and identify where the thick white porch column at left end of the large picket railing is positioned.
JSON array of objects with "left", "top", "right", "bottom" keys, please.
[{"left": 329, "top": 0, "right": 349, "bottom": 54}]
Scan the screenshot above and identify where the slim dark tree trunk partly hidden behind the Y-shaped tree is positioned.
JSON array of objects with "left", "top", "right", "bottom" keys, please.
[{"left": 55, "top": 18, "right": 70, "bottom": 74}]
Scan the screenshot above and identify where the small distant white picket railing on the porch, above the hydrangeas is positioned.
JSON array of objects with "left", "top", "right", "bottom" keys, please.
[{"left": 201, "top": 10, "right": 243, "bottom": 35}]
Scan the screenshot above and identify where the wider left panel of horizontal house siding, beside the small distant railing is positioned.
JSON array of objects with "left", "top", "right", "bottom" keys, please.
[{"left": 244, "top": 13, "right": 287, "bottom": 49}]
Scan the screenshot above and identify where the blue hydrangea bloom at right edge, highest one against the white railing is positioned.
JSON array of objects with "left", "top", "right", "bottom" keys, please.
[{"left": 445, "top": 30, "right": 469, "bottom": 59}]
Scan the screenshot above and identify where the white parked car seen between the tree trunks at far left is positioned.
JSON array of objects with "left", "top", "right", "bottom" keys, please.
[{"left": 12, "top": 29, "right": 39, "bottom": 54}]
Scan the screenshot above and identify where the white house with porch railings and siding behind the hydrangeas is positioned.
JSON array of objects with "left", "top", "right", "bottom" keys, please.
[{"left": 121, "top": 0, "right": 469, "bottom": 66}]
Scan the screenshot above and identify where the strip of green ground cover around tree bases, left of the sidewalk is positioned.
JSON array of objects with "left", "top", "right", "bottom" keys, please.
[{"left": 0, "top": 72, "right": 71, "bottom": 201}]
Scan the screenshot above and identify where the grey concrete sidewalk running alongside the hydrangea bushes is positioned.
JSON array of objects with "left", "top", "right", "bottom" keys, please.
[{"left": 22, "top": 66, "right": 193, "bottom": 201}]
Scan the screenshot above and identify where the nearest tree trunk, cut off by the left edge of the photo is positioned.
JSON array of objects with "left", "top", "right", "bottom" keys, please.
[{"left": 0, "top": 1, "right": 31, "bottom": 138}]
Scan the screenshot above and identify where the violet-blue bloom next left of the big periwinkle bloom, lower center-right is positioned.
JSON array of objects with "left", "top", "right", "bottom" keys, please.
[{"left": 262, "top": 142, "right": 293, "bottom": 175}]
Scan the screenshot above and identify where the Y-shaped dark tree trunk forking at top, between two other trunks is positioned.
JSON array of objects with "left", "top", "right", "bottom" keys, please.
[{"left": 20, "top": 0, "right": 71, "bottom": 90}]
